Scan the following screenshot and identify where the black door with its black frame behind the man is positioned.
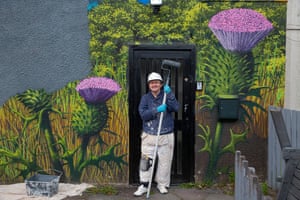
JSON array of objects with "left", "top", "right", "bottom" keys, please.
[{"left": 128, "top": 45, "right": 196, "bottom": 184}]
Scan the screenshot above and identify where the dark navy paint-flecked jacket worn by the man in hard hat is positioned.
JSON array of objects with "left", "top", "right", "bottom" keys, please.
[{"left": 139, "top": 90, "right": 179, "bottom": 135}]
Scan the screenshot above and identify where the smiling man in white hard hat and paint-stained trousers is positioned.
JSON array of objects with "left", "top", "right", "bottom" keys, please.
[{"left": 134, "top": 72, "right": 179, "bottom": 196}]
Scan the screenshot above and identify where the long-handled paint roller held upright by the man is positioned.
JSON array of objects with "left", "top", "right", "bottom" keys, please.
[{"left": 146, "top": 60, "right": 180, "bottom": 199}]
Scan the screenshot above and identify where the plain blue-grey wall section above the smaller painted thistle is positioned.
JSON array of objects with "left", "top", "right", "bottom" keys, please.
[{"left": 0, "top": 0, "right": 90, "bottom": 106}]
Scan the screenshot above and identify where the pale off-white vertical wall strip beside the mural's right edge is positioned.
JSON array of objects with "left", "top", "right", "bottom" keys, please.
[{"left": 284, "top": 0, "right": 300, "bottom": 110}]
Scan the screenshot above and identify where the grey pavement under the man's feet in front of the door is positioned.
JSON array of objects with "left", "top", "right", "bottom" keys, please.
[{"left": 64, "top": 185, "right": 234, "bottom": 200}]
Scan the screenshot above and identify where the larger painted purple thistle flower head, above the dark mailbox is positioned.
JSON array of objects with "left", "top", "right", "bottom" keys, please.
[{"left": 208, "top": 8, "right": 273, "bottom": 52}]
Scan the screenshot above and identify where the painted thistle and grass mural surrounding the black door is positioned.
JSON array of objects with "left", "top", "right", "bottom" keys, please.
[{"left": 0, "top": 0, "right": 286, "bottom": 183}]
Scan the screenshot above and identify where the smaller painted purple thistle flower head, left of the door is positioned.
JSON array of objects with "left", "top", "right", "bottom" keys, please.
[{"left": 76, "top": 77, "right": 121, "bottom": 104}]
